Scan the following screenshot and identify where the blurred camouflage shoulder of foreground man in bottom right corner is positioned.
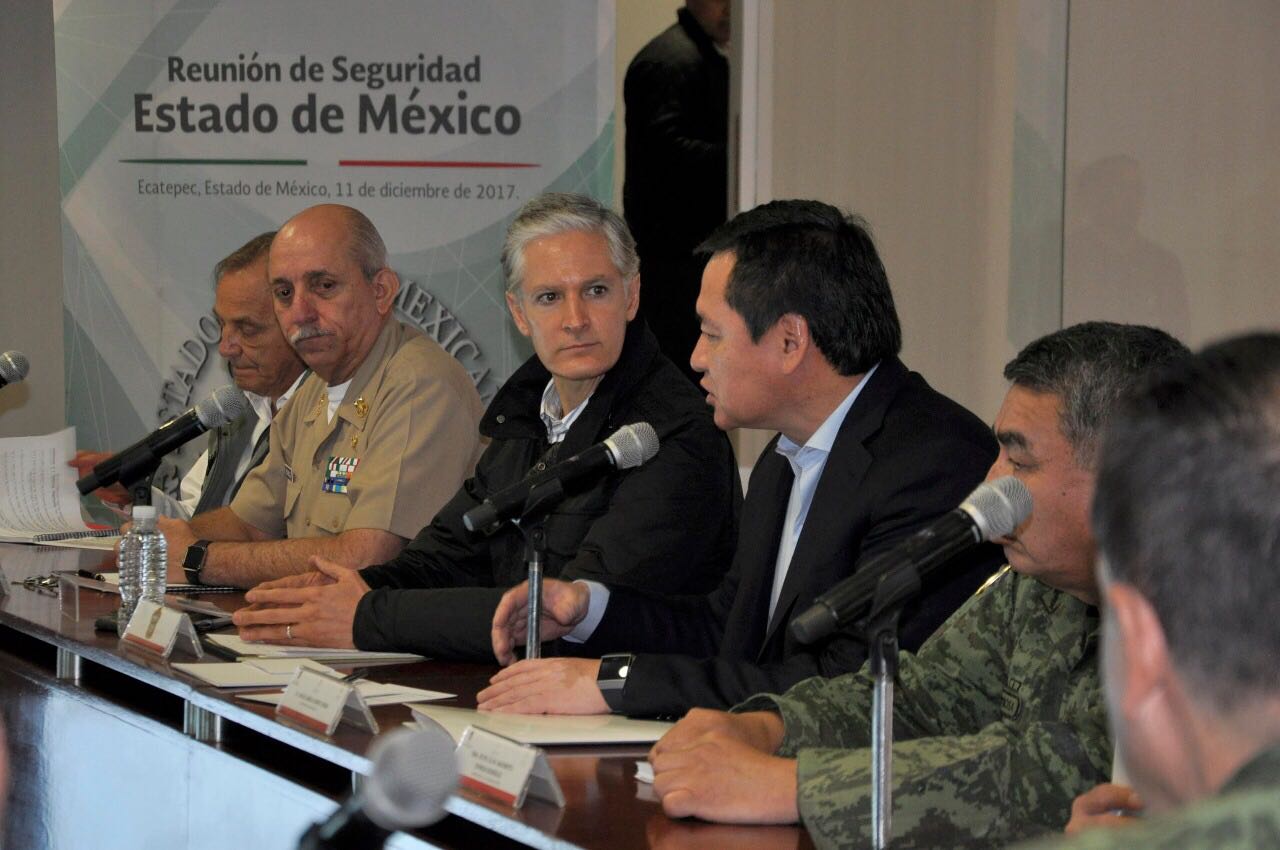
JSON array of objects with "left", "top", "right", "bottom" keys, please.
[{"left": 1013, "top": 746, "right": 1280, "bottom": 850}]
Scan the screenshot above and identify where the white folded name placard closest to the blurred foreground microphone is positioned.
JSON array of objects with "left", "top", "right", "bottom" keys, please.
[{"left": 458, "top": 726, "right": 564, "bottom": 809}]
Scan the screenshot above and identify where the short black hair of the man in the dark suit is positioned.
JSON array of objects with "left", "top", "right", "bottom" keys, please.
[{"left": 698, "top": 201, "right": 902, "bottom": 375}]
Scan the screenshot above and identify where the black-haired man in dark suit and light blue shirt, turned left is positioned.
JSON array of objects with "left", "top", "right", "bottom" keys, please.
[{"left": 479, "top": 201, "right": 1000, "bottom": 714}]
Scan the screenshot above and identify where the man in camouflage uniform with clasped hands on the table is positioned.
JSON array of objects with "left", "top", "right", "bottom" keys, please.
[{"left": 650, "top": 323, "right": 1187, "bottom": 847}]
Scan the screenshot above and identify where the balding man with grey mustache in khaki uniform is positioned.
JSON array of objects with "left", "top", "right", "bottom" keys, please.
[{"left": 160, "top": 205, "right": 481, "bottom": 591}]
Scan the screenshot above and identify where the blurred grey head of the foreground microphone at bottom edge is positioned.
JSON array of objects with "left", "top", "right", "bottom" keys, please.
[{"left": 364, "top": 728, "right": 458, "bottom": 831}]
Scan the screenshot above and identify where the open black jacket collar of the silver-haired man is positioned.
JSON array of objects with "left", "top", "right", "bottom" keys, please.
[{"left": 480, "top": 319, "right": 658, "bottom": 457}]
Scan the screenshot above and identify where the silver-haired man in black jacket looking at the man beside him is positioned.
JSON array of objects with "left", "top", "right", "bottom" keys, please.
[{"left": 237, "top": 193, "right": 741, "bottom": 659}]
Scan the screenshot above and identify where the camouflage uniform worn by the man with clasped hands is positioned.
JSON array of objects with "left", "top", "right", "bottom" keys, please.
[{"left": 733, "top": 567, "right": 1111, "bottom": 850}]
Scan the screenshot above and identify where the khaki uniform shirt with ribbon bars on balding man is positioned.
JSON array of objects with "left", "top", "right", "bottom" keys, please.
[{"left": 230, "top": 319, "right": 483, "bottom": 539}]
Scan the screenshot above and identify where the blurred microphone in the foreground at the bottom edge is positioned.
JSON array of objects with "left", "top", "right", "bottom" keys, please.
[{"left": 298, "top": 728, "right": 458, "bottom": 850}]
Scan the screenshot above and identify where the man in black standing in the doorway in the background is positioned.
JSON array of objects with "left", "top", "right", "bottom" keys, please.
[{"left": 622, "top": 0, "right": 730, "bottom": 383}]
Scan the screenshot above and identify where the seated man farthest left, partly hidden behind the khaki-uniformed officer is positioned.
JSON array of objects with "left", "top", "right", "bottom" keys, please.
[{"left": 68, "top": 230, "right": 306, "bottom": 520}]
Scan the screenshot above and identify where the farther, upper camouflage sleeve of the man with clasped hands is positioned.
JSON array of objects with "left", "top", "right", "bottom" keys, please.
[{"left": 733, "top": 573, "right": 1016, "bottom": 757}]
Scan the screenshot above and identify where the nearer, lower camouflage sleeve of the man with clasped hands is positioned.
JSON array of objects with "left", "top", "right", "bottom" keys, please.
[{"left": 797, "top": 722, "right": 1111, "bottom": 847}]
